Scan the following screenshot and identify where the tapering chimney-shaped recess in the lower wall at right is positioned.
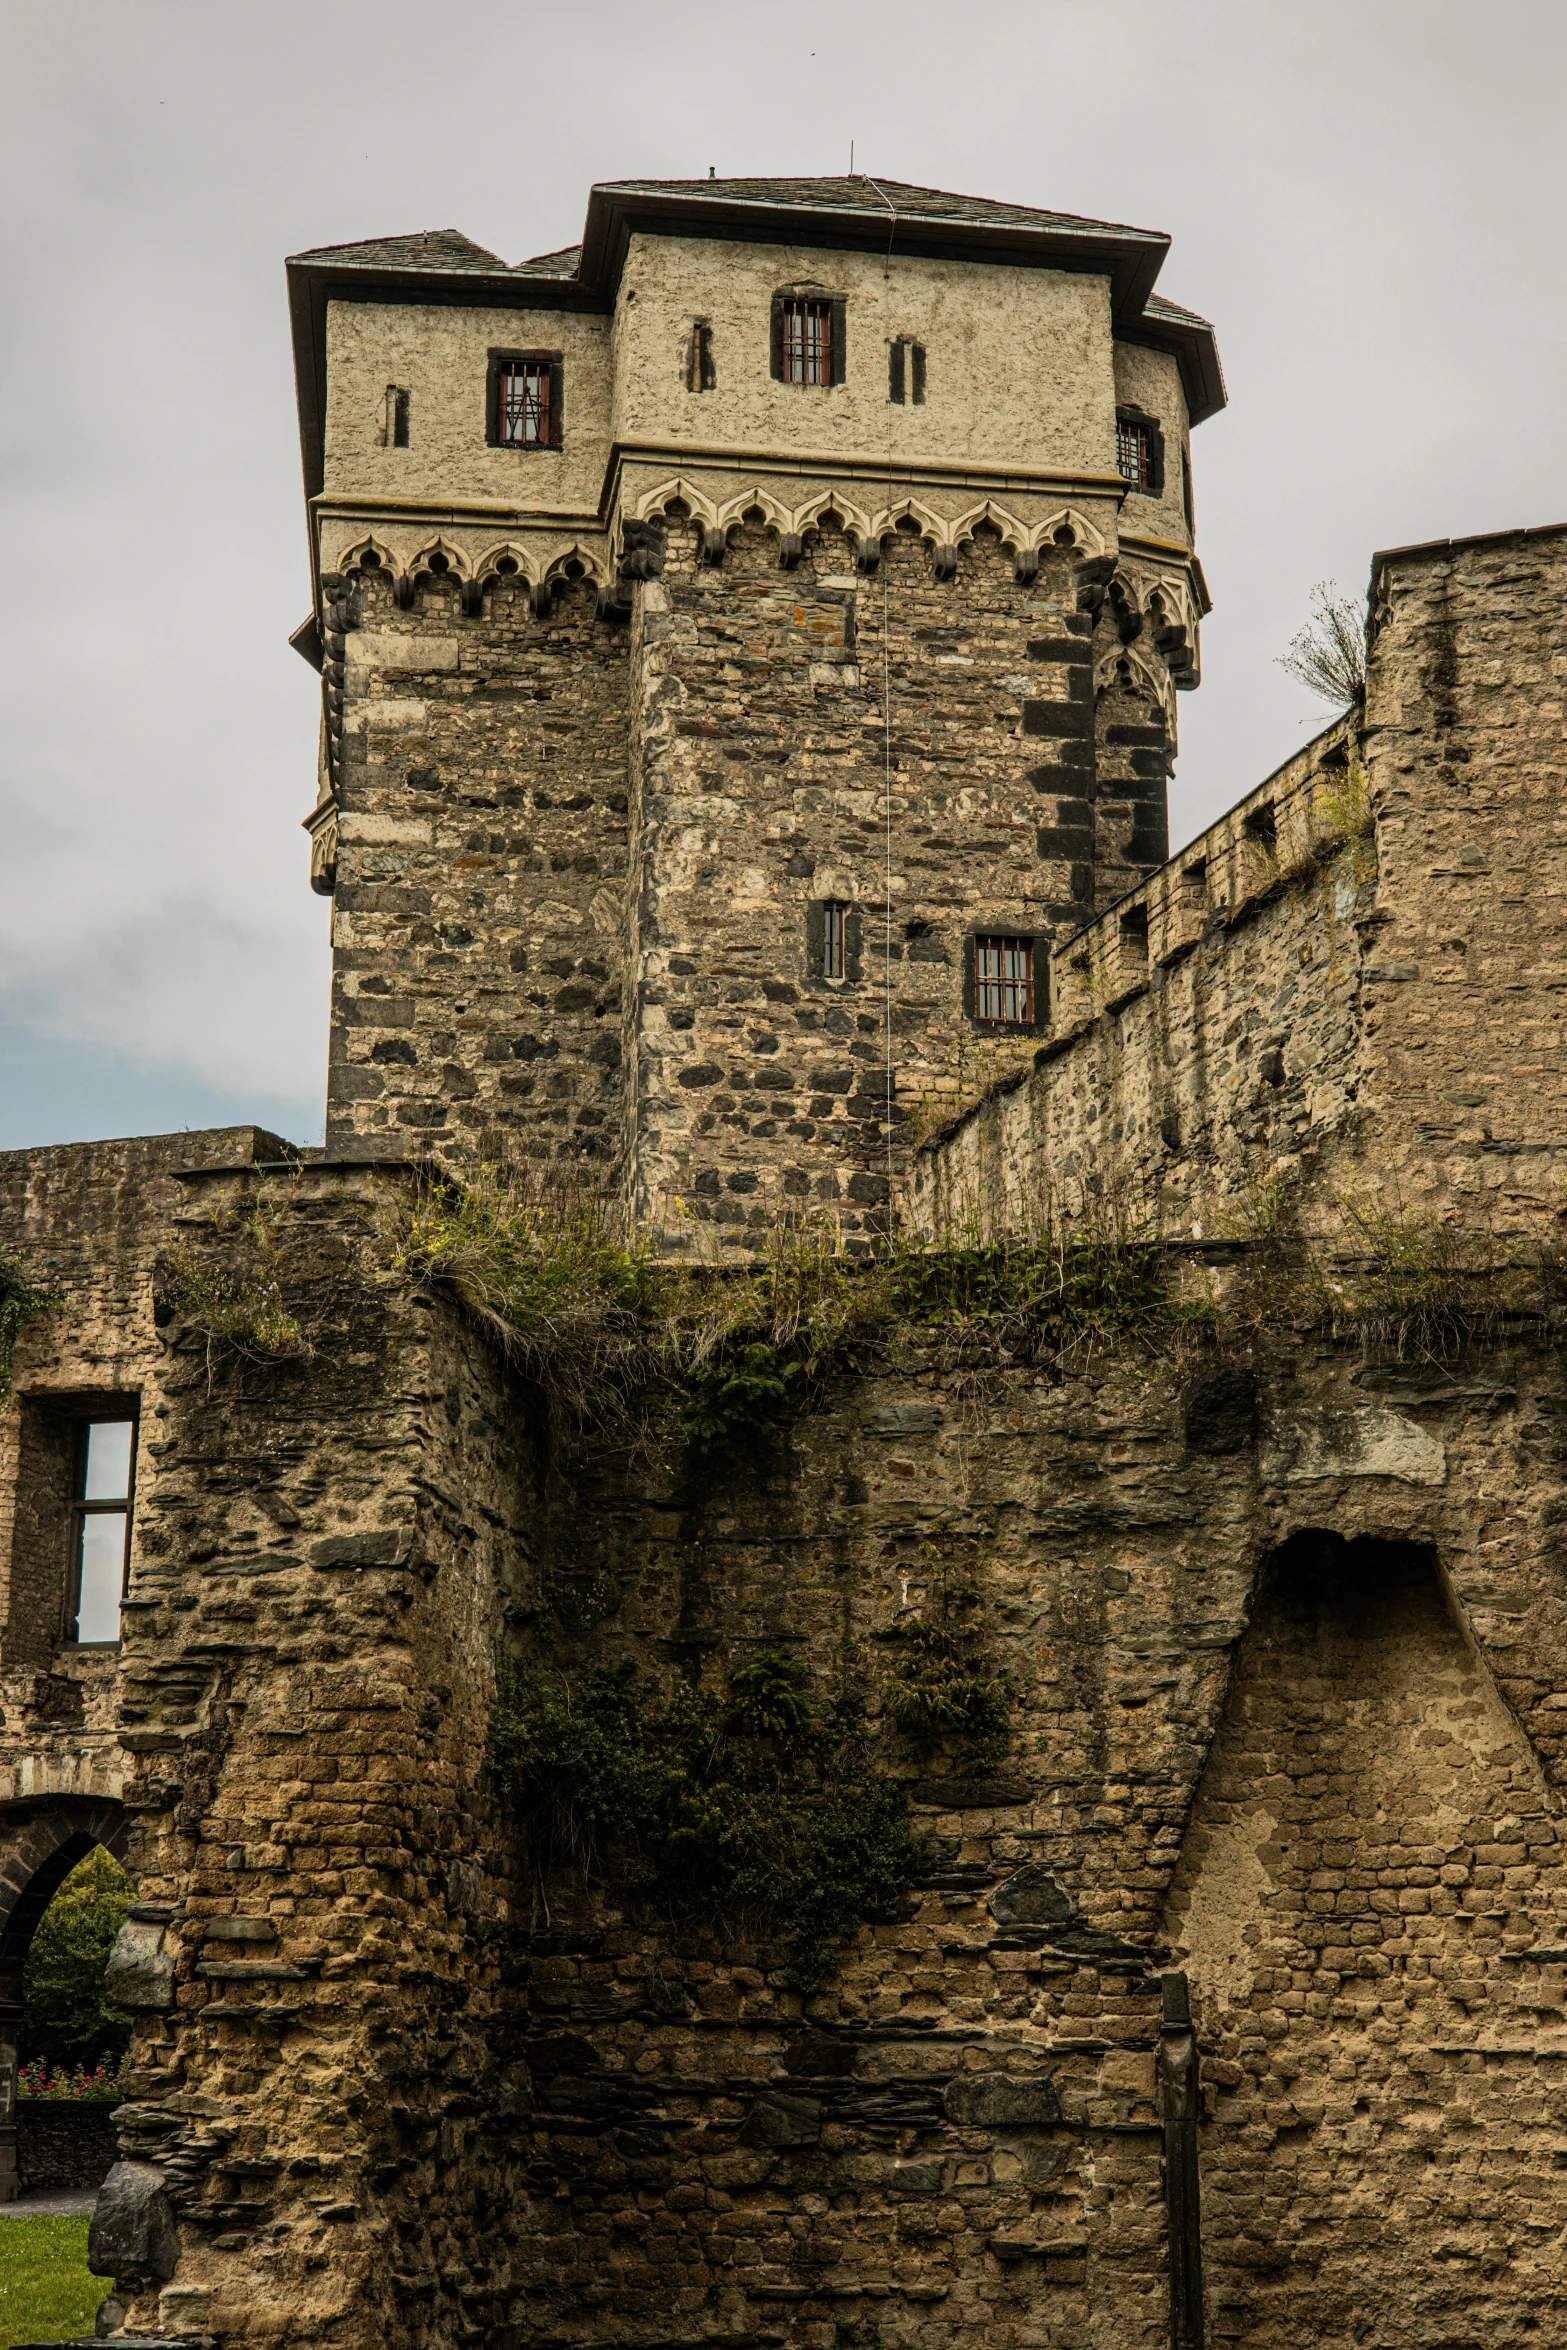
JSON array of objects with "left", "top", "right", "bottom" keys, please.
[{"left": 1165, "top": 1532, "right": 1567, "bottom": 2350}]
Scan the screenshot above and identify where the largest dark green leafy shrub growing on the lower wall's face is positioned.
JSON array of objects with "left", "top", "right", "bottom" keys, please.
[{"left": 489, "top": 1650, "right": 923, "bottom": 1990}]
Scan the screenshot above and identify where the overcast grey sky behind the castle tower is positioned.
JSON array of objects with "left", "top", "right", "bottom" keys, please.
[{"left": 0, "top": 0, "right": 1567, "bottom": 1147}]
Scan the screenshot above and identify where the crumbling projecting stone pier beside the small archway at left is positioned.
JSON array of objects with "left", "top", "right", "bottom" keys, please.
[{"left": 106, "top": 1173, "right": 533, "bottom": 2350}]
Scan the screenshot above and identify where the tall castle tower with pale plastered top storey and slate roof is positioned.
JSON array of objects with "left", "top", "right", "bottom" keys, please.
[{"left": 289, "top": 176, "right": 1224, "bottom": 1238}]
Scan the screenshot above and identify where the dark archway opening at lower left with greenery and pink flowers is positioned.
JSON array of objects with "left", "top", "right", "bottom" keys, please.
[{"left": 0, "top": 1798, "right": 134, "bottom": 2202}]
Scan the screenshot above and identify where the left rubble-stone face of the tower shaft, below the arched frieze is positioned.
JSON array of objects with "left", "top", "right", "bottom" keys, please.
[{"left": 327, "top": 569, "right": 627, "bottom": 1159}]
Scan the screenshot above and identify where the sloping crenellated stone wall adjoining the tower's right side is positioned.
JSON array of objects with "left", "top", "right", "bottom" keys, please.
[{"left": 912, "top": 531, "right": 1565, "bottom": 1236}]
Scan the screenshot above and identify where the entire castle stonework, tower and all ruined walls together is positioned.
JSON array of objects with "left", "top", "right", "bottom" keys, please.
[{"left": 0, "top": 181, "right": 1567, "bottom": 2350}]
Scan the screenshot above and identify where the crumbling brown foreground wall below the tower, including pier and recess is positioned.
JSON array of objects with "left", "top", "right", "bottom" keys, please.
[{"left": 18, "top": 1166, "right": 1567, "bottom": 2350}]
